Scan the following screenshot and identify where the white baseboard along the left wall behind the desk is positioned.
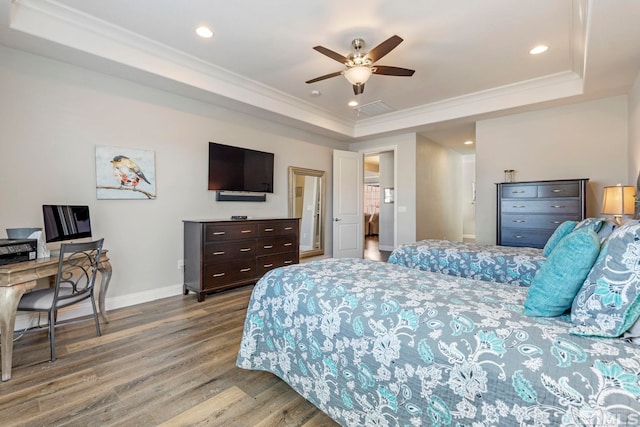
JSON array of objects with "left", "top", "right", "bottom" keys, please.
[{"left": 14, "top": 285, "right": 182, "bottom": 331}]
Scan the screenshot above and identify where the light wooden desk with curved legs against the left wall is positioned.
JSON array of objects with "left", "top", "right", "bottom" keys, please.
[{"left": 0, "top": 251, "right": 111, "bottom": 381}]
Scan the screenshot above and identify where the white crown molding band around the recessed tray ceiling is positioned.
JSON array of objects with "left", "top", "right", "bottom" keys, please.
[{"left": 9, "top": 0, "right": 592, "bottom": 139}]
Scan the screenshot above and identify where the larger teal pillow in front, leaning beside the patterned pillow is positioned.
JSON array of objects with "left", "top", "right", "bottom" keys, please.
[{"left": 524, "top": 228, "right": 600, "bottom": 317}]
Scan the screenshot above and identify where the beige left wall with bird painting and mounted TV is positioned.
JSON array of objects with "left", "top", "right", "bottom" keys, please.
[{"left": 0, "top": 47, "right": 338, "bottom": 307}]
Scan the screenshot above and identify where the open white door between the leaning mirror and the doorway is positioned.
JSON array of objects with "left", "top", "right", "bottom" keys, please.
[{"left": 333, "top": 150, "right": 364, "bottom": 258}]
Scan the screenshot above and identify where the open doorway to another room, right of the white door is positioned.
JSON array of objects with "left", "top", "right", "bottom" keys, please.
[{"left": 363, "top": 151, "right": 395, "bottom": 261}]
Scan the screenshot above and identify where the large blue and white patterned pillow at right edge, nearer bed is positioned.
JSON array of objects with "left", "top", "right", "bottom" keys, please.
[{"left": 571, "top": 221, "right": 640, "bottom": 337}]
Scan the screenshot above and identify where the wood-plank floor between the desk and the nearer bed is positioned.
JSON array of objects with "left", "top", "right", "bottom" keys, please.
[{"left": 0, "top": 286, "right": 337, "bottom": 427}]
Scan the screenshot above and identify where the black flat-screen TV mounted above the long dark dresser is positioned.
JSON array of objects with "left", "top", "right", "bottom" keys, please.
[{"left": 209, "top": 142, "right": 274, "bottom": 193}]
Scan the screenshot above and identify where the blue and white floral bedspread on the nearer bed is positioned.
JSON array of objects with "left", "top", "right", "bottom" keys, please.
[{"left": 237, "top": 259, "right": 640, "bottom": 426}]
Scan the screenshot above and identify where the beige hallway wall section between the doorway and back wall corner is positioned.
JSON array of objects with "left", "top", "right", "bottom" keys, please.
[{"left": 416, "top": 136, "right": 463, "bottom": 242}]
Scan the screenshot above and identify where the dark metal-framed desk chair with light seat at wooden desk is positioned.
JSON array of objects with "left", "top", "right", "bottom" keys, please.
[{"left": 18, "top": 239, "right": 104, "bottom": 362}]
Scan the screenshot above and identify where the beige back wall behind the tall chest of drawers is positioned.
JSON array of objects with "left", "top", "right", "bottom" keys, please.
[{"left": 476, "top": 96, "right": 637, "bottom": 244}]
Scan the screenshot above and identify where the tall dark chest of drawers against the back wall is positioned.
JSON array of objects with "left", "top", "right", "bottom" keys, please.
[{"left": 496, "top": 178, "right": 589, "bottom": 248}]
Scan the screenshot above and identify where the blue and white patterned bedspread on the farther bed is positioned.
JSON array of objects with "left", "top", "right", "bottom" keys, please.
[{"left": 389, "top": 240, "right": 546, "bottom": 286}]
